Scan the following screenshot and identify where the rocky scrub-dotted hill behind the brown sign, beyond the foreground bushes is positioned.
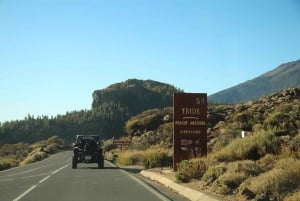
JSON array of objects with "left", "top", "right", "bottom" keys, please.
[{"left": 125, "top": 88, "right": 300, "bottom": 151}]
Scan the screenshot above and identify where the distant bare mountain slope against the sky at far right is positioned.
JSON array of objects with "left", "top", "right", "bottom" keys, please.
[{"left": 208, "top": 60, "right": 300, "bottom": 103}]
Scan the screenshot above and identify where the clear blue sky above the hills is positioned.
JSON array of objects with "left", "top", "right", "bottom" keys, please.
[{"left": 0, "top": 0, "right": 300, "bottom": 122}]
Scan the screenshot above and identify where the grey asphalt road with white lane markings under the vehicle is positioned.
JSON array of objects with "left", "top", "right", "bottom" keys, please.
[{"left": 0, "top": 151, "right": 185, "bottom": 201}]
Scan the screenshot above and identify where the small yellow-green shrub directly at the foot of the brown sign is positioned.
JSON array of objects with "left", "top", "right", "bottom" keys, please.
[{"left": 175, "top": 158, "right": 208, "bottom": 182}]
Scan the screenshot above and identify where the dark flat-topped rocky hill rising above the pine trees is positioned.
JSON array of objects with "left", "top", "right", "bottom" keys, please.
[{"left": 92, "top": 79, "right": 180, "bottom": 116}]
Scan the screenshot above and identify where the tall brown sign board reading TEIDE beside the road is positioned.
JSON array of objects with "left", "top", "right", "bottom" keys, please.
[{"left": 173, "top": 93, "right": 207, "bottom": 171}]
